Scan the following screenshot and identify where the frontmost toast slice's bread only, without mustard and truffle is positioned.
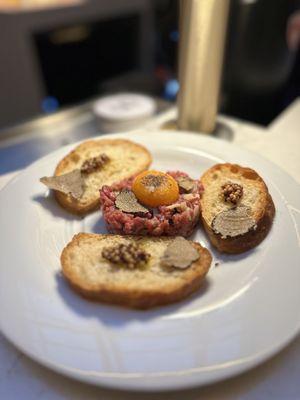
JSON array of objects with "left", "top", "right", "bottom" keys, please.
[{"left": 61, "top": 233, "right": 212, "bottom": 309}]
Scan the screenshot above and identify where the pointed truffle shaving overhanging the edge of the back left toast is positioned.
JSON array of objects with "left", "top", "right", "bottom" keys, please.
[{"left": 40, "top": 169, "right": 84, "bottom": 199}]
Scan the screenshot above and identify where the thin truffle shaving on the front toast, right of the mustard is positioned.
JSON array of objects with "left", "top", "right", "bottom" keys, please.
[{"left": 162, "top": 236, "right": 200, "bottom": 269}]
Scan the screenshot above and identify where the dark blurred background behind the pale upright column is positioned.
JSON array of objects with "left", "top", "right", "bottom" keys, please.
[{"left": 0, "top": 0, "right": 300, "bottom": 129}]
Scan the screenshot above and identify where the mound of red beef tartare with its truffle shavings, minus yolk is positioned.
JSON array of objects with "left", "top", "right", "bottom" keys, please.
[{"left": 100, "top": 171, "right": 203, "bottom": 237}]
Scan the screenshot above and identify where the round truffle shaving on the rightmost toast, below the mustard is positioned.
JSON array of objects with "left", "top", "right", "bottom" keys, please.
[{"left": 212, "top": 206, "right": 256, "bottom": 239}]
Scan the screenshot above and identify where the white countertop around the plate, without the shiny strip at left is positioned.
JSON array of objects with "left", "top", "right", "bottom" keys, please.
[{"left": 0, "top": 100, "right": 300, "bottom": 400}]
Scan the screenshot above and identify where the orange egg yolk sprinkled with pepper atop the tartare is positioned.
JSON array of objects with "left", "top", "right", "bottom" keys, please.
[{"left": 132, "top": 171, "right": 179, "bottom": 207}]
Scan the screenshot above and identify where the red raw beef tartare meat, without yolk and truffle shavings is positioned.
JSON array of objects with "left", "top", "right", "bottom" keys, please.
[{"left": 100, "top": 171, "right": 203, "bottom": 237}]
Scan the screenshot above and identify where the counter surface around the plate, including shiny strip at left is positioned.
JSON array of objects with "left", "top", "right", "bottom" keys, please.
[{"left": 0, "top": 100, "right": 300, "bottom": 400}]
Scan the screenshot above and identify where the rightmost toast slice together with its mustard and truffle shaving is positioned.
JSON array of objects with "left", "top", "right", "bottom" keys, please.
[{"left": 201, "top": 163, "right": 275, "bottom": 253}]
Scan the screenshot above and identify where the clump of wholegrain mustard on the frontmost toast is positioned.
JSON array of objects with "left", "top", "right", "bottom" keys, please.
[{"left": 102, "top": 243, "right": 150, "bottom": 269}]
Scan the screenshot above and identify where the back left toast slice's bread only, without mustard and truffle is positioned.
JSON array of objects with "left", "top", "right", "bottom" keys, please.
[{"left": 55, "top": 139, "right": 152, "bottom": 215}]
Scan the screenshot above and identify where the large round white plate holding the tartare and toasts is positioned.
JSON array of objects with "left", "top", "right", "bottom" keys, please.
[{"left": 0, "top": 131, "right": 300, "bottom": 391}]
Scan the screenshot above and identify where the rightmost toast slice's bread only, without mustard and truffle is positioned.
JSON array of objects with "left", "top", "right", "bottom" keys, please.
[{"left": 201, "top": 164, "right": 275, "bottom": 253}]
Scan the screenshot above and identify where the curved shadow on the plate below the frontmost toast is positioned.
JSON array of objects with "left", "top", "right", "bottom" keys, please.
[{"left": 56, "top": 272, "right": 211, "bottom": 327}]
